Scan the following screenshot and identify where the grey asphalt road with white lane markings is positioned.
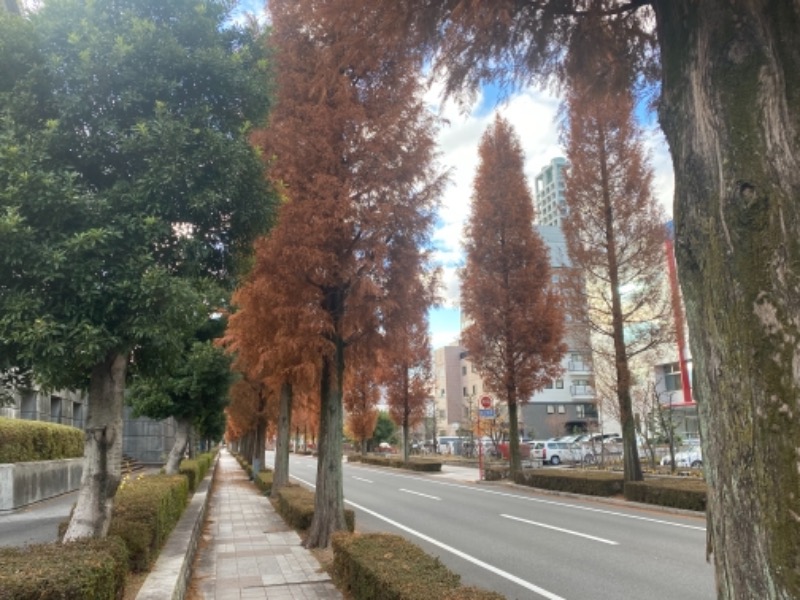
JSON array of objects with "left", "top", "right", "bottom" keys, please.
[{"left": 282, "top": 456, "right": 715, "bottom": 600}]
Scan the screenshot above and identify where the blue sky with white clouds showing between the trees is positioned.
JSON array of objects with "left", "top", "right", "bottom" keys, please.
[{"left": 230, "top": 0, "right": 674, "bottom": 348}]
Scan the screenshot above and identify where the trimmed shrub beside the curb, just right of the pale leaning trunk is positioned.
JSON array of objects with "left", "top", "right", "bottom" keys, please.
[{"left": 109, "top": 475, "right": 189, "bottom": 572}]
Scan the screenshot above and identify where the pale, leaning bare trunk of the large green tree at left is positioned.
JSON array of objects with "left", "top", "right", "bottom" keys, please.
[{"left": 64, "top": 353, "right": 128, "bottom": 542}]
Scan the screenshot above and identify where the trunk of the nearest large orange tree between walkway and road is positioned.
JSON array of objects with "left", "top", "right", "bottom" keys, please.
[{"left": 305, "top": 339, "right": 346, "bottom": 548}]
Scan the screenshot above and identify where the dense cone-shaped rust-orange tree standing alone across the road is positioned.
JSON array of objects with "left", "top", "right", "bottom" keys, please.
[{"left": 461, "top": 117, "right": 566, "bottom": 473}]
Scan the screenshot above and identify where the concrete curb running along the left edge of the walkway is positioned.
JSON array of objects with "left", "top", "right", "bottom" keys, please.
[{"left": 136, "top": 456, "right": 219, "bottom": 600}]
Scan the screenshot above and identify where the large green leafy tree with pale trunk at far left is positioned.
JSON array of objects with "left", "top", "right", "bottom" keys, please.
[{"left": 0, "top": 0, "right": 271, "bottom": 540}]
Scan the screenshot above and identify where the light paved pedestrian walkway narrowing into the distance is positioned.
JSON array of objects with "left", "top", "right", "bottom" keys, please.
[{"left": 188, "top": 449, "right": 342, "bottom": 600}]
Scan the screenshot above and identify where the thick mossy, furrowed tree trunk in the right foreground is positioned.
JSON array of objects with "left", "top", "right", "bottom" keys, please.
[{"left": 654, "top": 0, "right": 800, "bottom": 599}]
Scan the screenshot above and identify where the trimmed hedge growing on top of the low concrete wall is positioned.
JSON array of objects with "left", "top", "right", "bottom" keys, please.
[{"left": 0, "top": 417, "right": 84, "bottom": 463}]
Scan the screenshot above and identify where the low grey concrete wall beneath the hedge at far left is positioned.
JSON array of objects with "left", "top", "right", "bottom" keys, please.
[{"left": 0, "top": 458, "right": 83, "bottom": 511}]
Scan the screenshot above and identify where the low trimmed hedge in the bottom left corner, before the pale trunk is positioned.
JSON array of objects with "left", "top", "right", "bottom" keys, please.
[{"left": 0, "top": 537, "right": 128, "bottom": 600}]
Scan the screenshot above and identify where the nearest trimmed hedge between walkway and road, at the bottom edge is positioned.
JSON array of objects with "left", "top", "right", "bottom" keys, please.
[{"left": 332, "top": 532, "right": 503, "bottom": 600}]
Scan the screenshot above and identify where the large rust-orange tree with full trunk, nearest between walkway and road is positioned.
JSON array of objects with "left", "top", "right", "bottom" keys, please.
[{"left": 252, "top": 0, "right": 442, "bottom": 547}]
